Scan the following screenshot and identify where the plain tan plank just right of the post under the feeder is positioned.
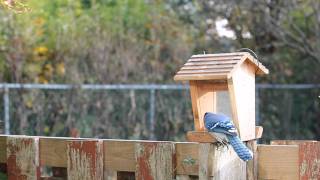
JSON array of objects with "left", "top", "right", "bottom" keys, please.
[{"left": 258, "top": 145, "right": 299, "bottom": 180}]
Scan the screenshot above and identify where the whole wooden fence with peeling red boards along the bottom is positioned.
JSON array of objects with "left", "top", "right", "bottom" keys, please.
[{"left": 0, "top": 135, "right": 320, "bottom": 180}]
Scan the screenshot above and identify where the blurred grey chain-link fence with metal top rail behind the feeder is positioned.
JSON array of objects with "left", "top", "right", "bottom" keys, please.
[{"left": 0, "top": 84, "right": 320, "bottom": 141}]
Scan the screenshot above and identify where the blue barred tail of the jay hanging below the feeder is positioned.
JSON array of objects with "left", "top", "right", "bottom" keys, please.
[{"left": 227, "top": 135, "right": 253, "bottom": 161}]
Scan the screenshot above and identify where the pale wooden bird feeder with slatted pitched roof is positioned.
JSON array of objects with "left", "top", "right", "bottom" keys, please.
[{"left": 174, "top": 52, "right": 269, "bottom": 141}]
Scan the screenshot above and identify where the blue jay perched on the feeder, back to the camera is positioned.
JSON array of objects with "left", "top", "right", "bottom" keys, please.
[{"left": 204, "top": 112, "right": 253, "bottom": 161}]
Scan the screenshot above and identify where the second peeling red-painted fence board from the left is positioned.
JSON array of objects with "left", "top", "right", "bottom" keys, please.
[{"left": 67, "top": 140, "right": 103, "bottom": 180}]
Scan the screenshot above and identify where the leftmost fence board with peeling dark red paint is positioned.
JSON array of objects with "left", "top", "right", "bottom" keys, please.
[{"left": 7, "top": 136, "right": 40, "bottom": 180}]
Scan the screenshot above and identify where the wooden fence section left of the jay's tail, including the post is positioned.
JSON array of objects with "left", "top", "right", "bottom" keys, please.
[{"left": 0, "top": 135, "right": 251, "bottom": 180}]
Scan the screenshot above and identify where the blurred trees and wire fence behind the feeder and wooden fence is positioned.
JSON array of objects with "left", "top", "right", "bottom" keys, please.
[{"left": 0, "top": 0, "right": 320, "bottom": 141}]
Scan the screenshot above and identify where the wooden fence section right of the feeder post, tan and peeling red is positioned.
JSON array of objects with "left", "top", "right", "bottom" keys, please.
[{"left": 257, "top": 140, "right": 320, "bottom": 180}]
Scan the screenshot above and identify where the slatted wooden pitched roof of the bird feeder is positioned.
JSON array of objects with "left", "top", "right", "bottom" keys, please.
[{"left": 174, "top": 52, "right": 269, "bottom": 81}]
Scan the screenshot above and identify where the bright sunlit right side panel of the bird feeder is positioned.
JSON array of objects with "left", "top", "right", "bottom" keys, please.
[{"left": 228, "top": 63, "right": 255, "bottom": 141}]
